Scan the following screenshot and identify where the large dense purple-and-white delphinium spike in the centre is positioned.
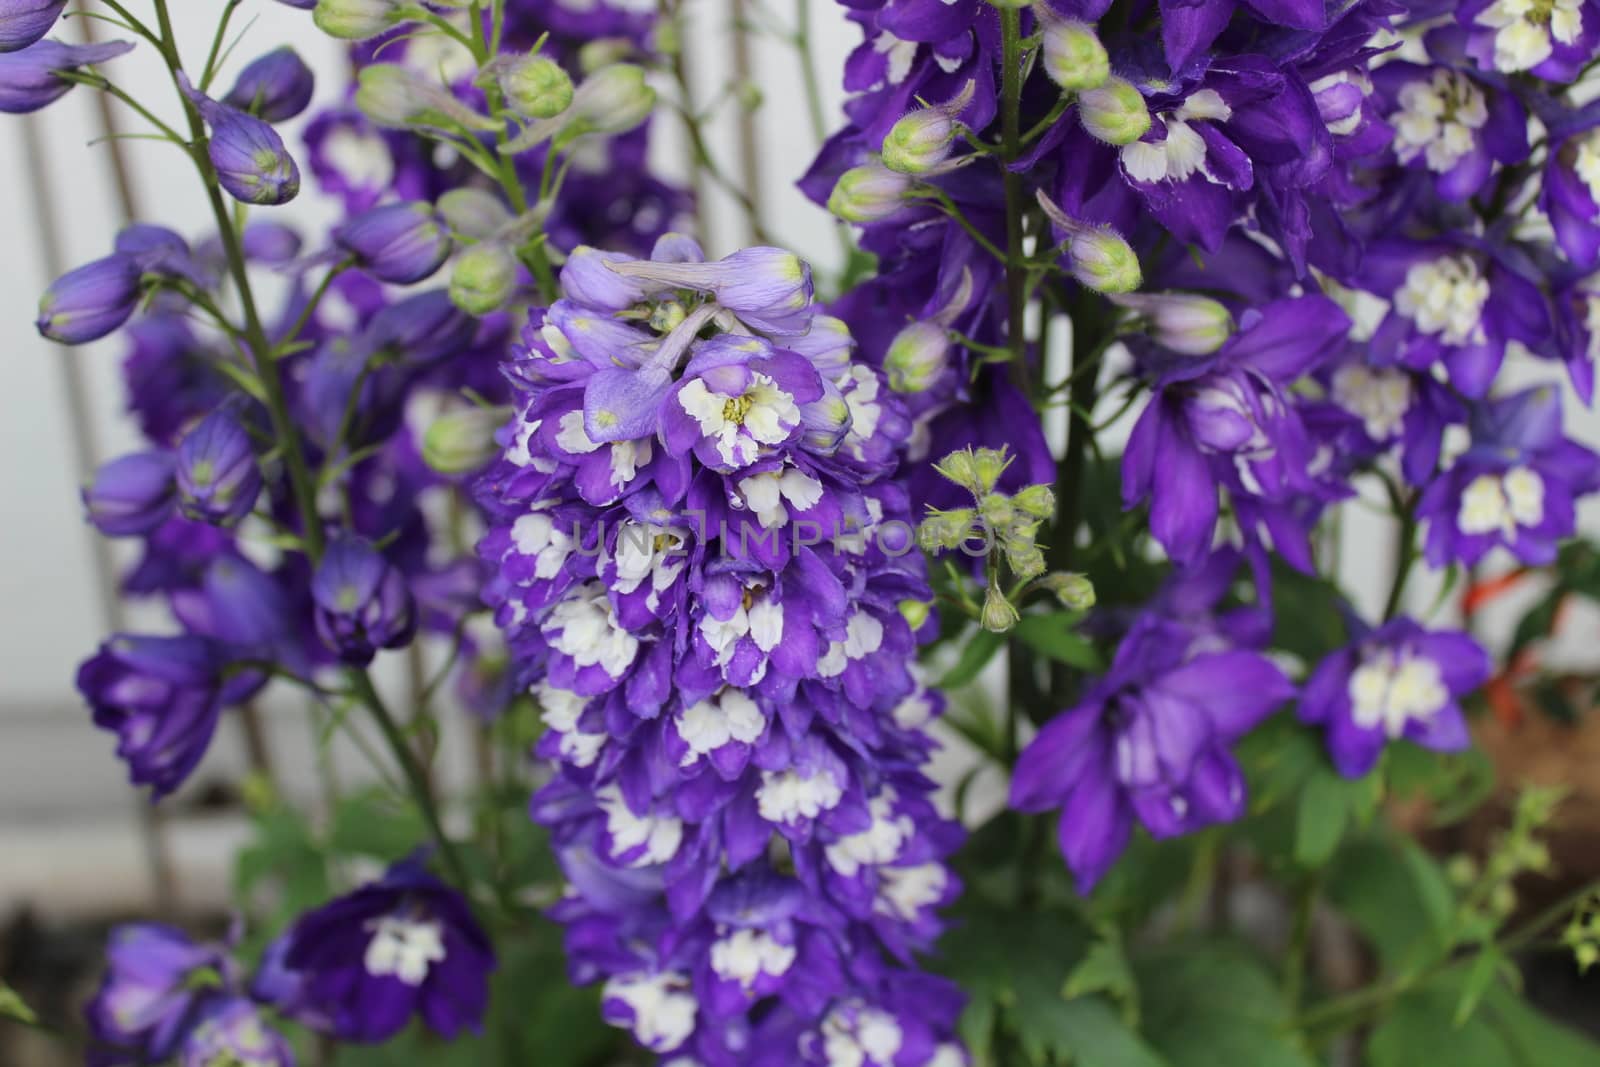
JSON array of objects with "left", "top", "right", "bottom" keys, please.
[{"left": 480, "top": 235, "right": 962, "bottom": 1067}]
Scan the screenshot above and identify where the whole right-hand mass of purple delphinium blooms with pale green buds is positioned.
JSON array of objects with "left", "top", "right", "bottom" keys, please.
[{"left": 803, "top": 0, "right": 1600, "bottom": 888}]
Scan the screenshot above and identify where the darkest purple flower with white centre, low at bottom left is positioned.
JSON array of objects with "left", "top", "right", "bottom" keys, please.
[{"left": 283, "top": 861, "right": 494, "bottom": 1041}]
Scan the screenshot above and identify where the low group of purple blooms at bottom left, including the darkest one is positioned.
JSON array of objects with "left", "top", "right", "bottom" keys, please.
[{"left": 86, "top": 861, "right": 494, "bottom": 1067}]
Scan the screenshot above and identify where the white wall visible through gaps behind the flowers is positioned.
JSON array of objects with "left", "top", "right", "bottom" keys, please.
[{"left": 0, "top": 0, "right": 1600, "bottom": 910}]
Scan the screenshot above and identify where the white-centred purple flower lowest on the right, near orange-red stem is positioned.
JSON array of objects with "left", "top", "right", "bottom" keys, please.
[{"left": 1299, "top": 619, "right": 1490, "bottom": 777}]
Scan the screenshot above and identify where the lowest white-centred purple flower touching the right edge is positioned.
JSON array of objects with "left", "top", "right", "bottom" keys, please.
[{"left": 1416, "top": 386, "right": 1600, "bottom": 566}]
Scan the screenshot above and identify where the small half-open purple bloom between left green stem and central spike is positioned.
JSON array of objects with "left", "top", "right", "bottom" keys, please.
[{"left": 310, "top": 537, "right": 416, "bottom": 664}]
